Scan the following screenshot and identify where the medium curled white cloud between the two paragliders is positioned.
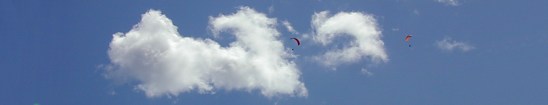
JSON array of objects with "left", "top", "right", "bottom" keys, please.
[{"left": 312, "top": 11, "right": 388, "bottom": 66}]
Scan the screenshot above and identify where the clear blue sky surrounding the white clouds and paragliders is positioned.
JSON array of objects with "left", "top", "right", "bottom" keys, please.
[{"left": 0, "top": 0, "right": 548, "bottom": 105}]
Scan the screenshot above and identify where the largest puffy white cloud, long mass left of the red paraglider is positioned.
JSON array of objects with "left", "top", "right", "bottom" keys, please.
[{"left": 106, "top": 7, "right": 308, "bottom": 97}]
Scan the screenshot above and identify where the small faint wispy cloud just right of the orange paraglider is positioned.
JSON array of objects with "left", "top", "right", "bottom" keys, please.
[{"left": 436, "top": 37, "right": 474, "bottom": 52}]
